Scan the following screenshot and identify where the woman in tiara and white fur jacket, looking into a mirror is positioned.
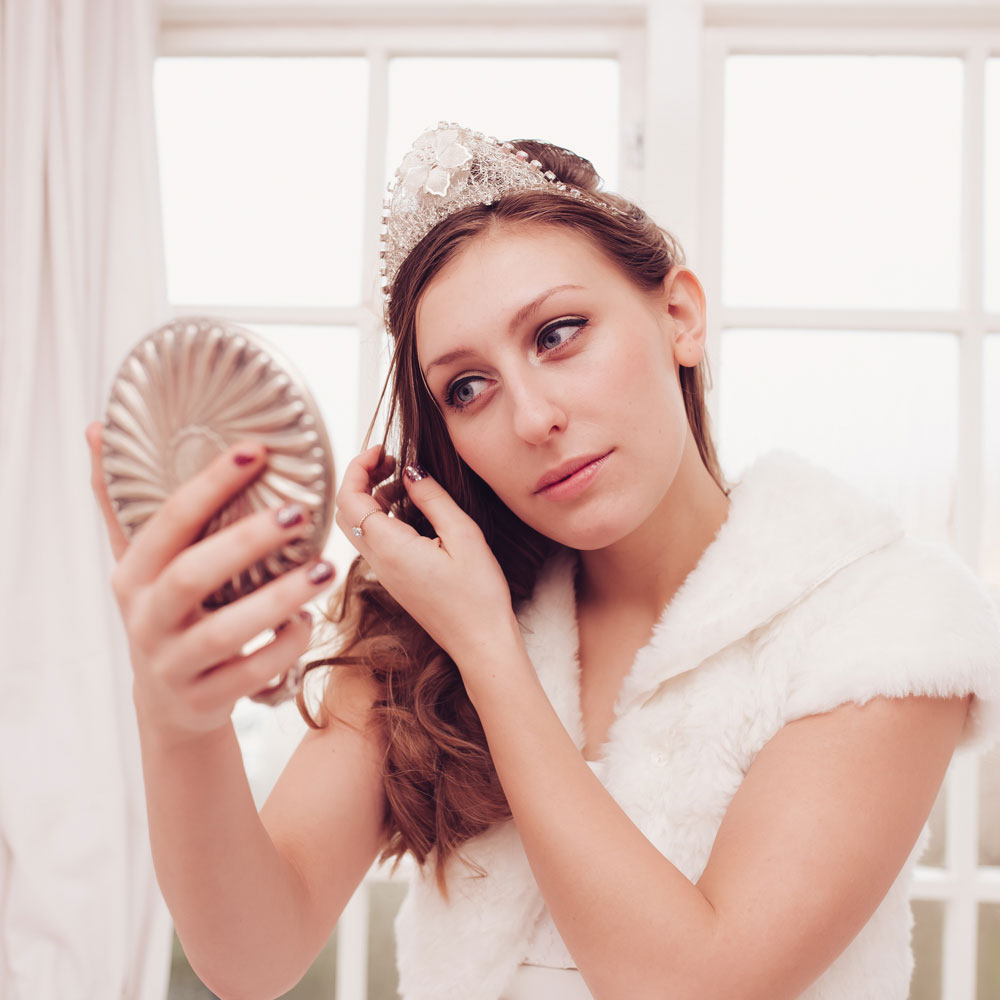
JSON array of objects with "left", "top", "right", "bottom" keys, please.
[{"left": 89, "top": 125, "right": 1000, "bottom": 1000}]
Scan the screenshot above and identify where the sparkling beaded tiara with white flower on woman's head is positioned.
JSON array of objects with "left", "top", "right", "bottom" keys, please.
[{"left": 379, "top": 122, "right": 624, "bottom": 303}]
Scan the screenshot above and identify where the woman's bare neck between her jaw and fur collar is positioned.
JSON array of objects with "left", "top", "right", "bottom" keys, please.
[{"left": 577, "top": 432, "right": 729, "bottom": 618}]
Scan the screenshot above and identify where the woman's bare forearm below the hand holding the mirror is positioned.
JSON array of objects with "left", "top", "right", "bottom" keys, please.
[{"left": 140, "top": 724, "right": 320, "bottom": 1000}]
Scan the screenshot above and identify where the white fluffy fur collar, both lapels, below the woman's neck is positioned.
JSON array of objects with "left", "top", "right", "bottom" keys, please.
[{"left": 518, "top": 450, "right": 903, "bottom": 747}]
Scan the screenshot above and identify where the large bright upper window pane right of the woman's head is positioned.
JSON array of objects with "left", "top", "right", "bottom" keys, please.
[{"left": 723, "top": 56, "right": 962, "bottom": 309}]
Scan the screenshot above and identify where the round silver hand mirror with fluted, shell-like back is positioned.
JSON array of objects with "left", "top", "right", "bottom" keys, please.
[{"left": 103, "top": 316, "right": 335, "bottom": 610}]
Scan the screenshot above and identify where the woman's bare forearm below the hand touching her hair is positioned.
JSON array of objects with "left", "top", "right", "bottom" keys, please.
[{"left": 466, "top": 651, "right": 716, "bottom": 998}]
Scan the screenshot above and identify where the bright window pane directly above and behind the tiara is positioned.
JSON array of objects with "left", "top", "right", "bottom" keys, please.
[{"left": 386, "top": 56, "right": 619, "bottom": 191}]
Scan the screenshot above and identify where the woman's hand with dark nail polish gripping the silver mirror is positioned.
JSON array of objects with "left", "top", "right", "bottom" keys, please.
[{"left": 87, "top": 422, "right": 333, "bottom": 739}]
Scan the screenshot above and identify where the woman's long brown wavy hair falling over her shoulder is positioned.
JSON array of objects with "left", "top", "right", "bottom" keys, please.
[{"left": 298, "top": 140, "right": 725, "bottom": 889}]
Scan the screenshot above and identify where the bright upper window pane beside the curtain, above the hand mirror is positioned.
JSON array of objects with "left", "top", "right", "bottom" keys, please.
[{"left": 156, "top": 58, "right": 368, "bottom": 306}]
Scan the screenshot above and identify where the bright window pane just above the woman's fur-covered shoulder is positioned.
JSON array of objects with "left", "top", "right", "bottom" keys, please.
[{"left": 719, "top": 330, "right": 958, "bottom": 541}]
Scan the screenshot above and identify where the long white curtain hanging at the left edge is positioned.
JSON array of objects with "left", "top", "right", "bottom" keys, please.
[{"left": 0, "top": 0, "right": 170, "bottom": 1000}]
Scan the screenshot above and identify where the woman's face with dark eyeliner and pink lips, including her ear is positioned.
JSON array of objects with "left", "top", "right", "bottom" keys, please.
[{"left": 416, "top": 226, "right": 704, "bottom": 550}]
